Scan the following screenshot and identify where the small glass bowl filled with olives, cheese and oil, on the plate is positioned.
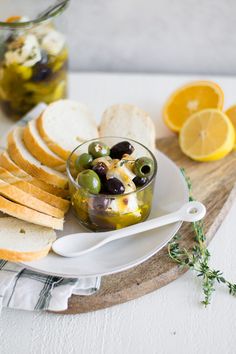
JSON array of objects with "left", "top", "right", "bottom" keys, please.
[{"left": 67, "top": 137, "right": 157, "bottom": 231}]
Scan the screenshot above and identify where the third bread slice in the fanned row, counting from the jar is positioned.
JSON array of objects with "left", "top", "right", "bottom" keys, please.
[{"left": 8, "top": 127, "right": 68, "bottom": 188}]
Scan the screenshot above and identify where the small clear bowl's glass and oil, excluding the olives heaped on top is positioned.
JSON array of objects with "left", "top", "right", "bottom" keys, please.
[{"left": 67, "top": 137, "right": 157, "bottom": 231}]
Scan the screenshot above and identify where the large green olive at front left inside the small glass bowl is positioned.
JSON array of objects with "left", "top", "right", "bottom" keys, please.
[{"left": 77, "top": 170, "right": 101, "bottom": 194}]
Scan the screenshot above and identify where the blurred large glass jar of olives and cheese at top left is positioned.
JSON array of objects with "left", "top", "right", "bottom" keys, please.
[{"left": 0, "top": 0, "right": 69, "bottom": 119}]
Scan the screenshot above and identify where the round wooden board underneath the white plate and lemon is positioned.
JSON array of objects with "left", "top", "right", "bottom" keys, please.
[{"left": 57, "top": 137, "right": 236, "bottom": 314}]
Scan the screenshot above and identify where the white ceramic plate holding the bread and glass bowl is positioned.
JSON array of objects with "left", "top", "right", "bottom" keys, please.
[{"left": 23, "top": 152, "right": 189, "bottom": 278}]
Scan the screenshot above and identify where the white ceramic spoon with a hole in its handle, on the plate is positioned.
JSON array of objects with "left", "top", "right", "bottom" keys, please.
[{"left": 52, "top": 201, "right": 206, "bottom": 258}]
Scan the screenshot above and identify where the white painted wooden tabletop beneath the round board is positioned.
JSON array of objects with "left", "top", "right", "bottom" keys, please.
[{"left": 0, "top": 74, "right": 236, "bottom": 354}]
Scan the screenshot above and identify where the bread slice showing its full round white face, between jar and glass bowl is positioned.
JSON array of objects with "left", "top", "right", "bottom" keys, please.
[{"left": 37, "top": 100, "right": 98, "bottom": 160}]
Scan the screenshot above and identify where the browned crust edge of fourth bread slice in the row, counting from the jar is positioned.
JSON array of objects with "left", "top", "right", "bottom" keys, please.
[{"left": 0, "top": 151, "right": 69, "bottom": 198}]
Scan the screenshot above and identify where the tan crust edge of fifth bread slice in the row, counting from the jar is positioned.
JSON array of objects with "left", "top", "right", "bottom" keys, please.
[{"left": 0, "top": 175, "right": 64, "bottom": 218}]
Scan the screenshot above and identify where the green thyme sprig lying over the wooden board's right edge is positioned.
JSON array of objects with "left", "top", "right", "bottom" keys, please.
[{"left": 168, "top": 169, "right": 236, "bottom": 306}]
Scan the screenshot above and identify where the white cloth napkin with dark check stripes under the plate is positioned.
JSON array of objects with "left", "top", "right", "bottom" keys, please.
[{"left": 0, "top": 260, "right": 101, "bottom": 312}]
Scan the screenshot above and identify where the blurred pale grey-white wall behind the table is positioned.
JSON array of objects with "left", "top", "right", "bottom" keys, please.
[{"left": 0, "top": 0, "right": 236, "bottom": 74}]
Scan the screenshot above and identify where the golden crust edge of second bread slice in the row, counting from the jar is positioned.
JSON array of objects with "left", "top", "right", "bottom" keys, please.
[{"left": 23, "top": 123, "right": 66, "bottom": 172}]
